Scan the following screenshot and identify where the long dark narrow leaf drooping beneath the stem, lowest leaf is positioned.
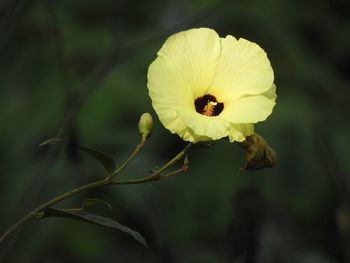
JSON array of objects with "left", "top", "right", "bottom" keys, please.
[{"left": 40, "top": 207, "right": 147, "bottom": 247}]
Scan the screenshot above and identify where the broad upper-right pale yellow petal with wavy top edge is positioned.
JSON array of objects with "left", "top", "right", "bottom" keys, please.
[{"left": 207, "top": 36, "right": 274, "bottom": 101}]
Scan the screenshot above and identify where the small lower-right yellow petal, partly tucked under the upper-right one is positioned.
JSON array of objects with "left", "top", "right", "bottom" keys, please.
[{"left": 220, "top": 84, "right": 276, "bottom": 123}]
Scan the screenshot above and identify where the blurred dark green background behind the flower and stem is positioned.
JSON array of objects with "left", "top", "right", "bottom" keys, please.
[{"left": 0, "top": 0, "right": 350, "bottom": 263}]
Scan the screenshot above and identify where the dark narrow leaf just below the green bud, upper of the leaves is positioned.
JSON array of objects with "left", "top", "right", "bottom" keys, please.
[{"left": 39, "top": 138, "right": 115, "bottom": 174}]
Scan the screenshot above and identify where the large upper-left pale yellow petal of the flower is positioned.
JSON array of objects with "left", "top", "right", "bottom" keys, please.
[{"left": 147, "top": 28, "right": 220, "bottom": 108}]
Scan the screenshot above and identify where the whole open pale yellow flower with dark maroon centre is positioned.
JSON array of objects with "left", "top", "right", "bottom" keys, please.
[{"left": 147, "top": 28, "right": 276, "bottom": 142}]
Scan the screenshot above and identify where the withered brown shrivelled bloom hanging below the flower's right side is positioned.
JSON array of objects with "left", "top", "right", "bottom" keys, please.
[{"left": 239, "top": 133, "right": 276, "bottom": 171}]
